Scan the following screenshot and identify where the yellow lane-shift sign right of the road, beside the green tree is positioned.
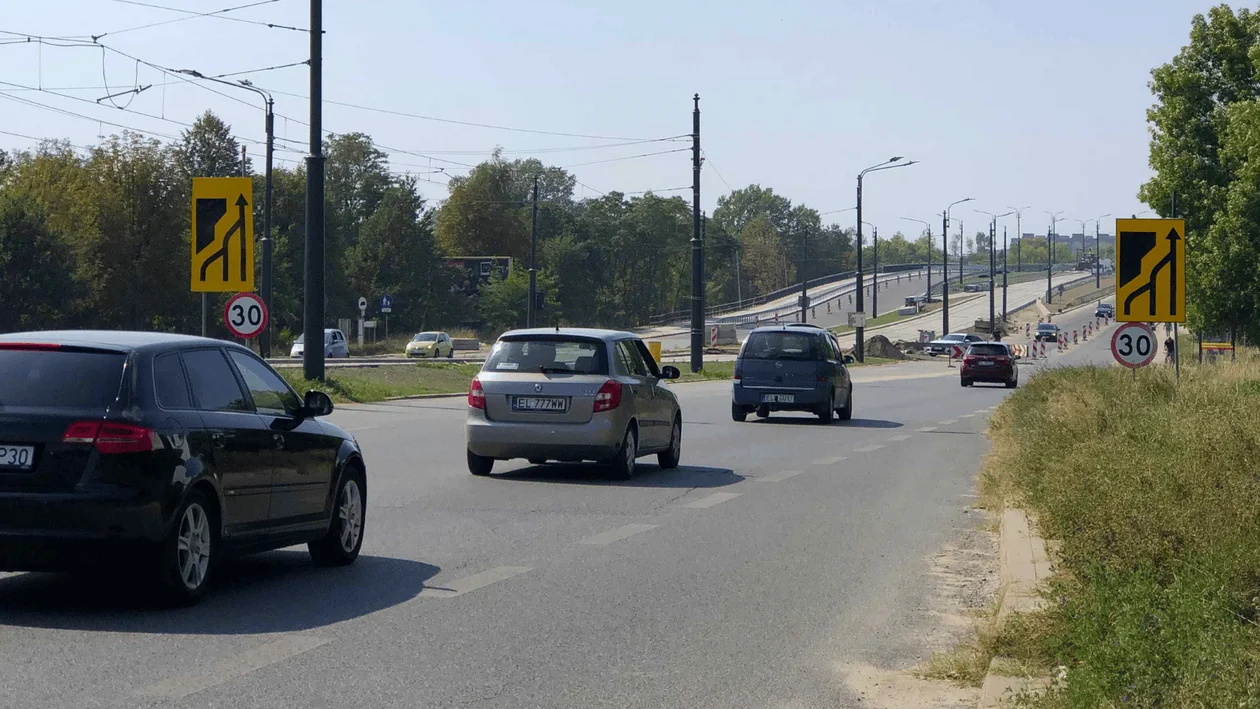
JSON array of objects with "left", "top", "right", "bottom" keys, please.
[{"left": 1115, "top": 219, "right": 1186, "bottom": 322}]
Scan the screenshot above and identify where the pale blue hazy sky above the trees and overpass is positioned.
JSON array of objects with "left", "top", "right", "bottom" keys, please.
[{"left": 0, "top": 0, "right": 1219, "bottom": 241}]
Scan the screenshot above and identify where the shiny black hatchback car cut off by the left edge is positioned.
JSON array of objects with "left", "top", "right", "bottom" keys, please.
[{"left": 0, "top": 331, "right": 367, "bottom": 602}]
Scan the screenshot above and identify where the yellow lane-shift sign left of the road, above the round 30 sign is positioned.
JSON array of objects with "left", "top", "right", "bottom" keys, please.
[{"left": 192, "top": 178, "right": 253, "bottom": 293}]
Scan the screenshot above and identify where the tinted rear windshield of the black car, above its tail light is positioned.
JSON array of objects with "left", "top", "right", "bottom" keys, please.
[{"left": 0, "top": 349, "right": 126, "bottom": 411}]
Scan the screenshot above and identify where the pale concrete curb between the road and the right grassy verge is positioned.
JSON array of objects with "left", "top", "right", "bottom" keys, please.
[{"left": 978, "top": 509, "right": 1053, "bottom": 709}]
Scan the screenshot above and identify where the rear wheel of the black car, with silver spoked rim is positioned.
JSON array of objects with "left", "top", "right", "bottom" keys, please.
[{"left": 159, "top": 490, "right": 219, "bottom": 606}]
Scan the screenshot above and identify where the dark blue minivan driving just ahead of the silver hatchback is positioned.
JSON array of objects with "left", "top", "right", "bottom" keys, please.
[{"left": 731, "top": 324, "right": 853, "bottom": 423}]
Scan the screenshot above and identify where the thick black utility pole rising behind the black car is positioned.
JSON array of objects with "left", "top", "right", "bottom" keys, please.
[{"left": 302, "top": 0, "right": 324, "bottom": 380}]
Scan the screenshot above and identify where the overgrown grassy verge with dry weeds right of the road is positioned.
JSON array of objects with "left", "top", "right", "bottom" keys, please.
[{"left": 980, "top": 356, "right": 1260, "bottom": 706}]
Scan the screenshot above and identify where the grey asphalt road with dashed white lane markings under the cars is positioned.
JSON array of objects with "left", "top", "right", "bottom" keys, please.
[{"left": 0, "top": 316, "right": 1114, "bottom": 709}]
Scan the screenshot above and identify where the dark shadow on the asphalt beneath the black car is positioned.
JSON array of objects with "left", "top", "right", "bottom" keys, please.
[{"left": 0, "top": 550, "right": 438, "bottom": 635}]
